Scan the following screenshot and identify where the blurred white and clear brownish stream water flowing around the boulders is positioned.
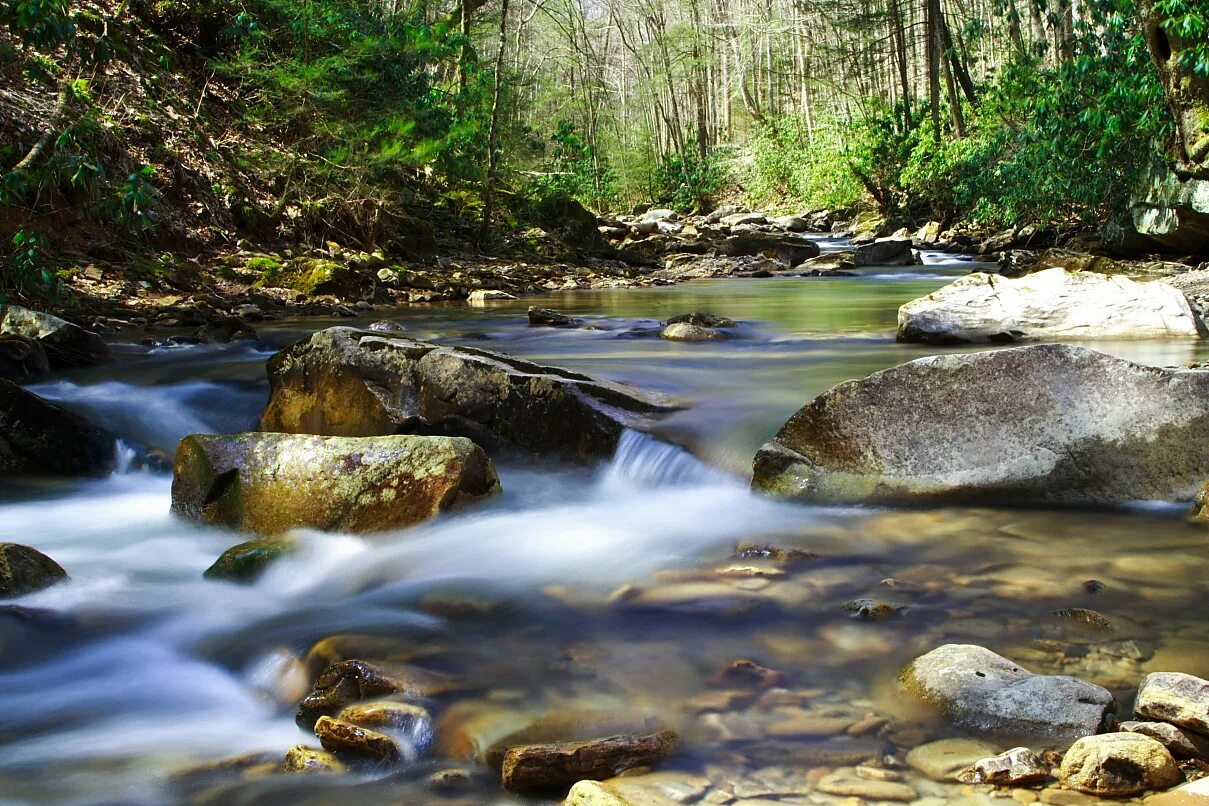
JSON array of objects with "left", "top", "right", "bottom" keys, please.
[{"left": 7, "top": 256, "right": 1209, "bottom": 804}]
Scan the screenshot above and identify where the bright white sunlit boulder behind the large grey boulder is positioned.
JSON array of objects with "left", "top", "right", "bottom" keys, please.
[{"left": 898, "top": 268, "right": 1201, "bottom": 344}]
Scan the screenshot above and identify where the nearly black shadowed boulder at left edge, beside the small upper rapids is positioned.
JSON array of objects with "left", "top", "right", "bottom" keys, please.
[{"left": 0, "top": 379, "right": 117, "bottom": 476}]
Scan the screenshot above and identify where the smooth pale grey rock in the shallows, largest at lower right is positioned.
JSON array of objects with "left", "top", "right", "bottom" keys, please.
[{"left": 899, "top": 644, "right": 1115, "bottom": 742}]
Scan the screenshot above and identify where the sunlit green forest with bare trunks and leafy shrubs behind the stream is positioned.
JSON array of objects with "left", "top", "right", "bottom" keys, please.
[{"left": 0, "top": 0, "right": 1209, "bottom": 296}]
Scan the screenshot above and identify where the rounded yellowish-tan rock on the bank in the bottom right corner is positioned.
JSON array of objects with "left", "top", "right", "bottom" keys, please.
[{"left": 1059, "top": 733, "right": 1184, "bottom": 798}]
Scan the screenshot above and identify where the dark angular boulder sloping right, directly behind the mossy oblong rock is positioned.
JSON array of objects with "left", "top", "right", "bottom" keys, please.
[{"left": 261, "top": 327, "right": 670, "bottom": 458}]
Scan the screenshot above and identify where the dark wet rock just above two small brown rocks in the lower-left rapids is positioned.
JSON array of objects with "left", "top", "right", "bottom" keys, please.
[{"left": 295, "top": 660, "right": 456, "bottom": 730}]
